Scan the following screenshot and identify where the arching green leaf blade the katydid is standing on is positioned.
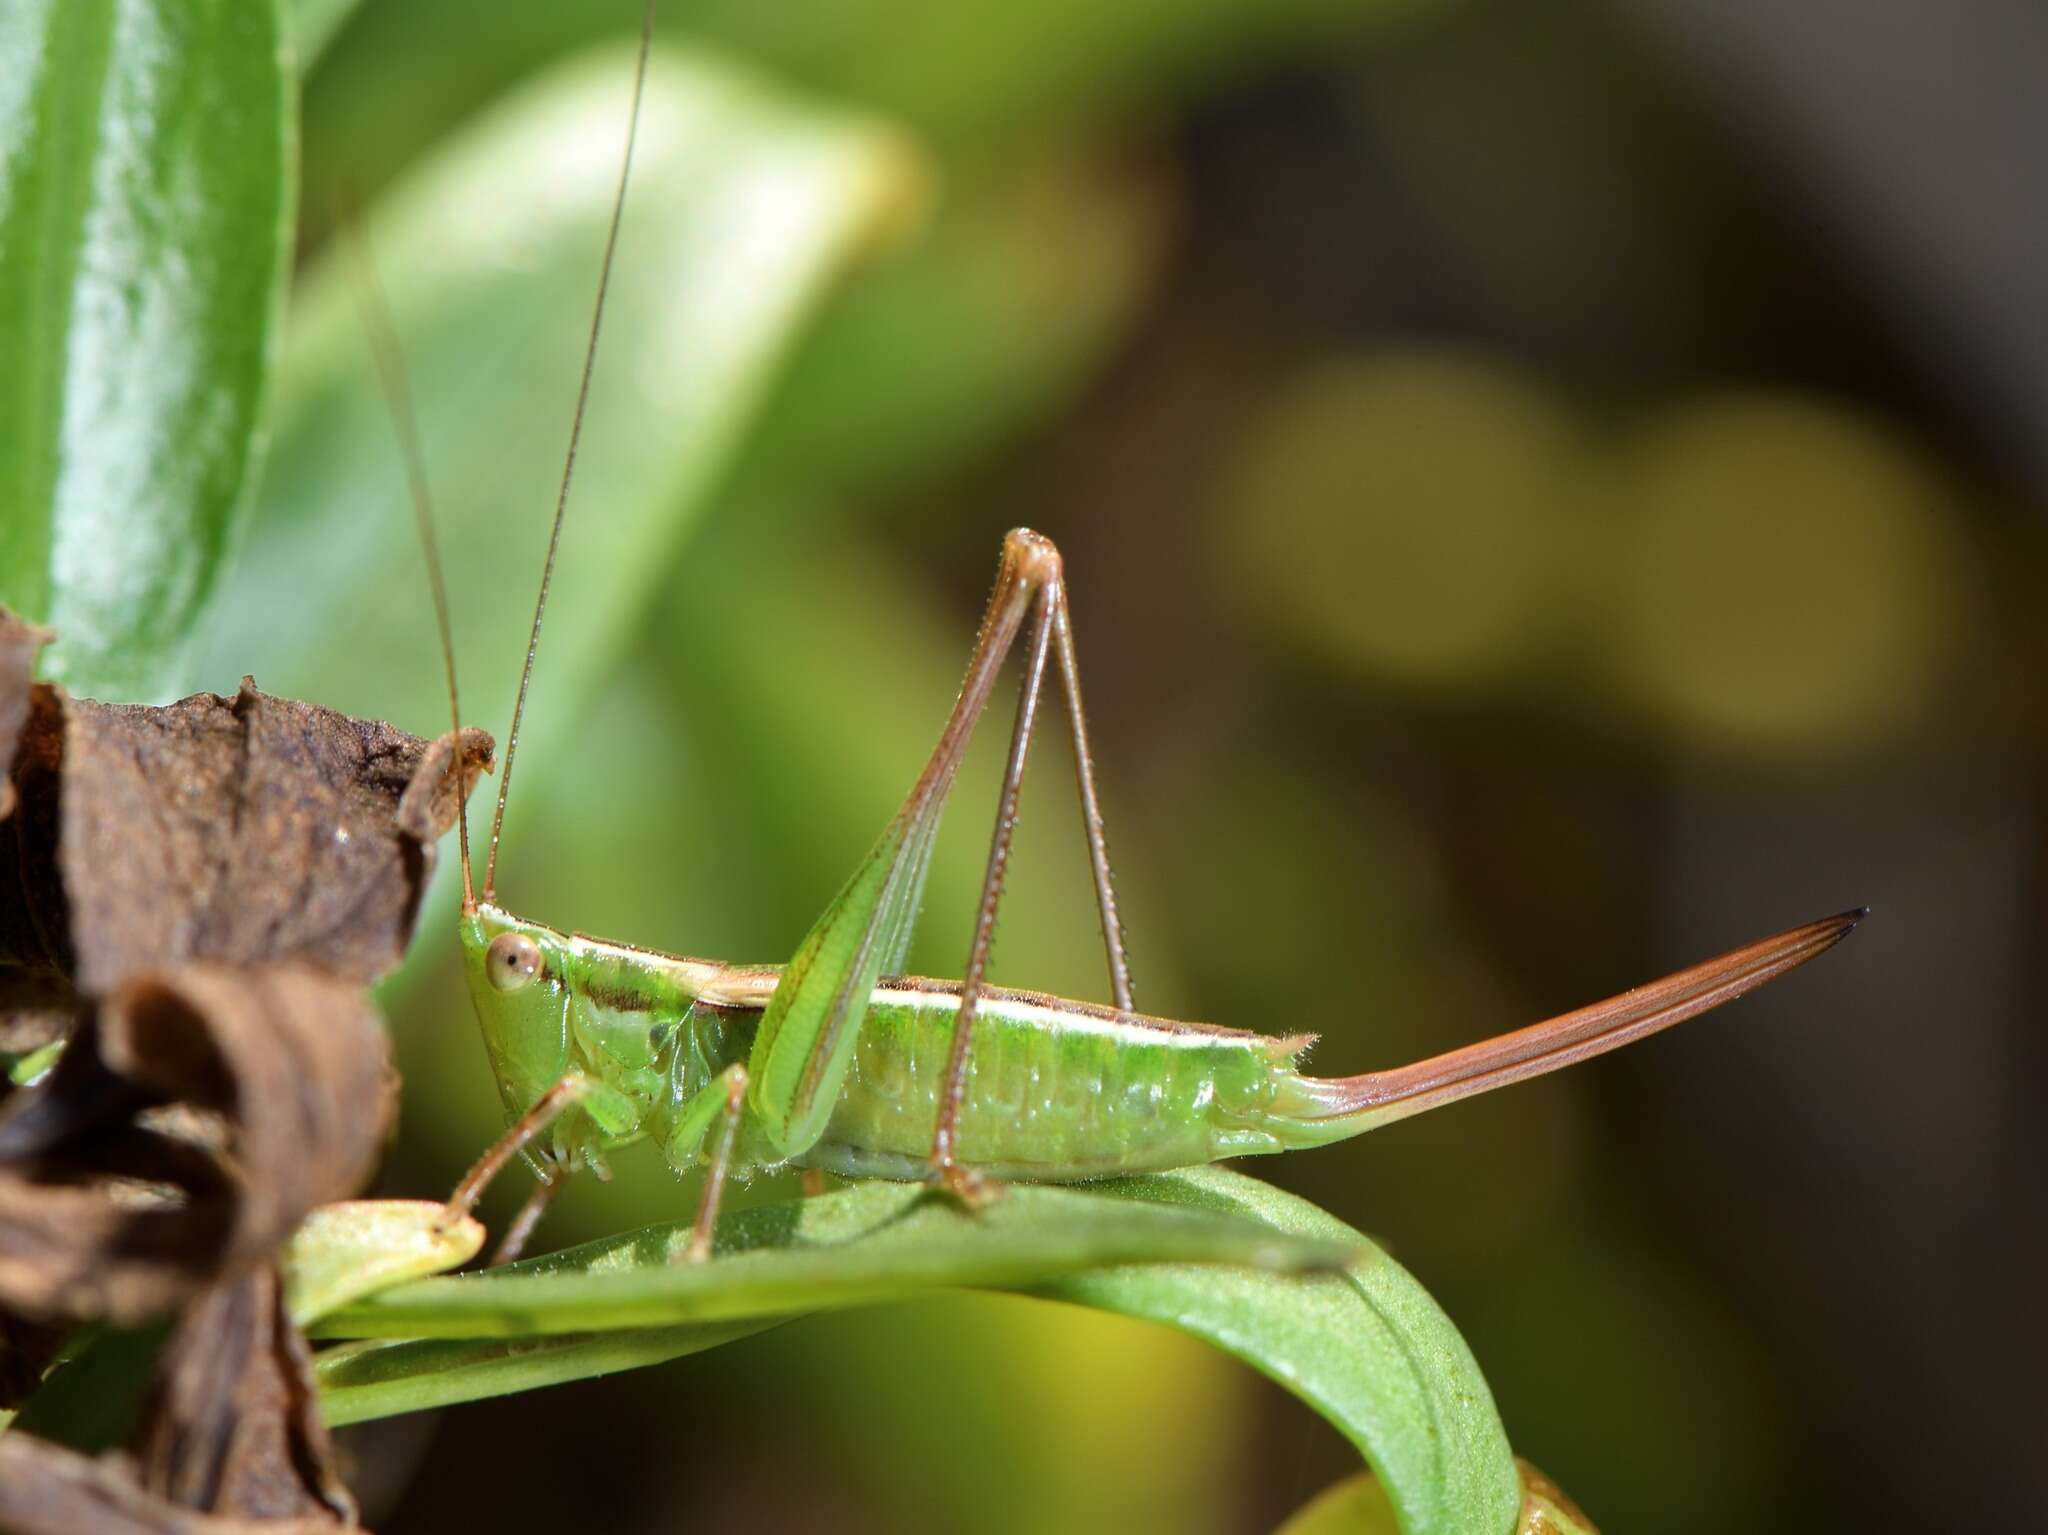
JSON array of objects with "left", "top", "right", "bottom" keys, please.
[{"left": 315, "top": 1169, "right": 1522, "bottom": 1535}]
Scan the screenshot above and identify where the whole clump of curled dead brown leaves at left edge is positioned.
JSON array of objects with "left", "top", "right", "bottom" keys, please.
[{"left": 0, "top": 612, "right": 492, "bottom": 1535}]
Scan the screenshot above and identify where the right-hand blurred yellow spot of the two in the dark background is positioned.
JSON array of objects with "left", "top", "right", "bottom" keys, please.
[{"left": 1606, "top": 397, "right": 1970, "bottom": 749}]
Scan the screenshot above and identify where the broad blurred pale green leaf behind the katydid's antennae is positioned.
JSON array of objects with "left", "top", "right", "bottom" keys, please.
[{"left": 205, "top": 39, "right": 924, "bottom": 867}]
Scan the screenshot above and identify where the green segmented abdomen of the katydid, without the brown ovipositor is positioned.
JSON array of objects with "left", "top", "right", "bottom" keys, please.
[{"left": 801, "top": 982, "right": 1300, "bottom": 1183}]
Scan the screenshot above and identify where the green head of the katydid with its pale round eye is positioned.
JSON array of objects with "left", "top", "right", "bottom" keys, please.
[{"left": 461, "top": 903, "right": 569, "bottom": 1117}]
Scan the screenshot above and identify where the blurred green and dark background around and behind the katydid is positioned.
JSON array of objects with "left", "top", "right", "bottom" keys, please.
[{"left": 211, "top": 0, "right": 2048, "bottom": 1535}]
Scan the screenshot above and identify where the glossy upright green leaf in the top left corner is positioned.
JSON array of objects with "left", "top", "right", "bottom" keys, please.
[{"left": 0, "top": 0, "right": 297, "bottom": 698}]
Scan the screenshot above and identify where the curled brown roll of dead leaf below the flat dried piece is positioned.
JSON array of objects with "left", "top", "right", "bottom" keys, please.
[{"left": 0, "top": 964, "right": 395, "bottom": 1322}]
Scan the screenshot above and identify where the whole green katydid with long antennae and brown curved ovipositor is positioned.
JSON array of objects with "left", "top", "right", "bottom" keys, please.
[{"left": 360, "top": 0, "right": 1862, "bottom": 1261}]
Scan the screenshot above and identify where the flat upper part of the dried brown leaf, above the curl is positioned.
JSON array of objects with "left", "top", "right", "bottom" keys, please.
[{"left": 0, "top": 679, "right": 489, "bottom": 997}]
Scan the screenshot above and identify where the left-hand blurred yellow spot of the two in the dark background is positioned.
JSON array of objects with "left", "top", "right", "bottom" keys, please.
[{"left": 1217, "top": 352, "right": 1579, "bottom": 684}]
